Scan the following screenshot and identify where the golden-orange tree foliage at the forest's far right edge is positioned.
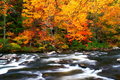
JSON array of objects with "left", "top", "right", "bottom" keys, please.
[{"left": 99, "top": 5, "right": 120, "bottom": 34}]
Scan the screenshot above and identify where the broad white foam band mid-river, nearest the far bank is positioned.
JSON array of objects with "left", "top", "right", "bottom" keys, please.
[{"left": 43, "top": 52, "right": 97, "bottom": 65}]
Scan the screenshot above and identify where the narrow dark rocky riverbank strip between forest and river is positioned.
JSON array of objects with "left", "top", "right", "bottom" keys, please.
[{"left": 0, "top": 47, "right": 120, "bottom": 54}]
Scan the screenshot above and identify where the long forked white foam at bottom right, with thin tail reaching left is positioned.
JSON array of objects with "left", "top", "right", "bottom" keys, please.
[{"left": 42, "top": 65, "right": 114, "bottom": 80}]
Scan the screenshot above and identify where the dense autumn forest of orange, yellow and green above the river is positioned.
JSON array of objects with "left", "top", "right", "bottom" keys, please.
[{"left": 0, "top": 0, "right": 120, "bottom": 52}]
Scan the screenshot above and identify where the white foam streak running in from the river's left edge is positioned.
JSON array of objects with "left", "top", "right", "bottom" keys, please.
[{"left": 0, "top": 54, "right": 38, "bottom": 75}]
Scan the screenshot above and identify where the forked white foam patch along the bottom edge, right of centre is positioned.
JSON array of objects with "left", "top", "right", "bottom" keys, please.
[{"left": 57, "top": 65, "right": 114, "bottom": 80}]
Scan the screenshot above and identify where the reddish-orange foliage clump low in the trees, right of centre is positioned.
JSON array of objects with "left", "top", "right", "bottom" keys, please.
[{"left": 65, "top": 18, "right": 92, "bottom": 42}]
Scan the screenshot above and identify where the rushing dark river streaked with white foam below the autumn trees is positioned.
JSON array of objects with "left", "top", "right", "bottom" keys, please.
[{"left": 0, "top": 50, "right": 120, "bottom": 80}]
